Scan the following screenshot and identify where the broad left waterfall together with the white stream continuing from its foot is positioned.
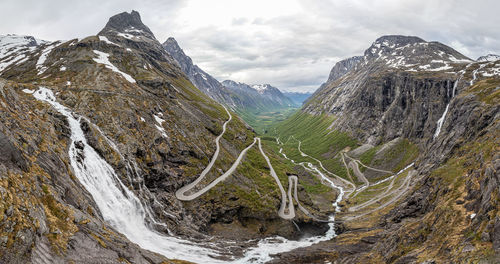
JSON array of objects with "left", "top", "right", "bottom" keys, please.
[{"left": 33, "top": 87, "right": 343, "bottom": 263}]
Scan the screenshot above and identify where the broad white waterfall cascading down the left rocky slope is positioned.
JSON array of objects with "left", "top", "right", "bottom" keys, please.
[{"left": 33, "top": 88, "right": 222, "bottom": 263}]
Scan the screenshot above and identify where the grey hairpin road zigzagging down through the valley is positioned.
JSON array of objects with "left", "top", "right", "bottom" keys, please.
[{"left": 175, "top": 106, "right": 413, "bottom": 222}]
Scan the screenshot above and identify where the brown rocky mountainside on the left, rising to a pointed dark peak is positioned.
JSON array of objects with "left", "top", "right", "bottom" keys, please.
[{"left": 0, "top": 11, "right": 332, "bottom": 263}]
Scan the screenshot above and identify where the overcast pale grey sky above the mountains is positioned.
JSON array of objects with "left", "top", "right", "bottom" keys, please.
[{"left": 0, "top": 0, "right": 500, "bottom": 91}]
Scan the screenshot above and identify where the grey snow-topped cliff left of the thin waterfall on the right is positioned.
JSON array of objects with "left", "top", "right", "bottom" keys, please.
[{"left": 304, "top": 36, "right": 478, "bottom": 144}]
